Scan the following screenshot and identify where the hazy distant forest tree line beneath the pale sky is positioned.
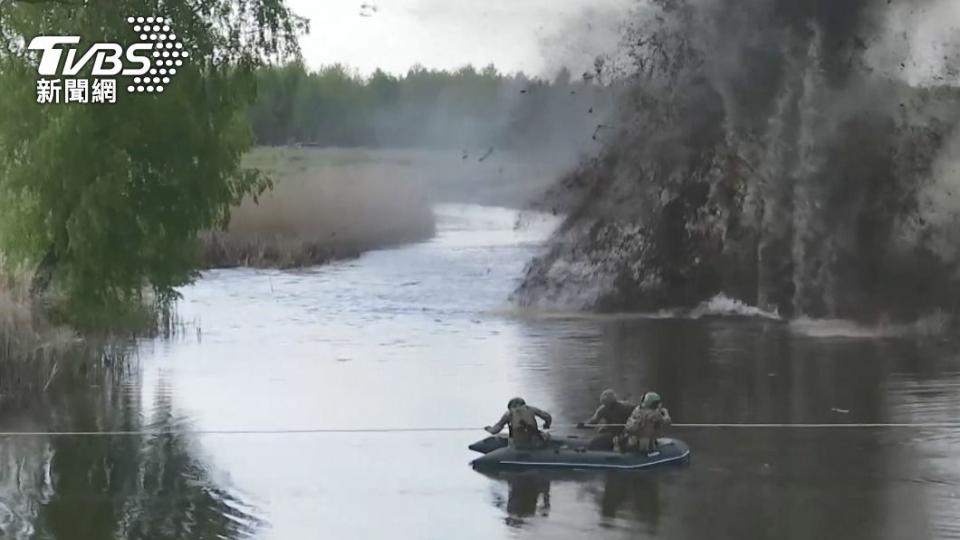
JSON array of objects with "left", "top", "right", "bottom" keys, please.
[{"left": 250, "top": 63, "right": 611, "bottom": 149}]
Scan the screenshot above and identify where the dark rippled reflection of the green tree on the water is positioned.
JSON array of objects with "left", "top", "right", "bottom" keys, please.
[{"left": 0, "top": 368, "right": 259, "bottom": 539}]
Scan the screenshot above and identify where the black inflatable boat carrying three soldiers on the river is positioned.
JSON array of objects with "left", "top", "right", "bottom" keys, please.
[{"left": 469, "top": 435, "right": 690, "bottom": 471}]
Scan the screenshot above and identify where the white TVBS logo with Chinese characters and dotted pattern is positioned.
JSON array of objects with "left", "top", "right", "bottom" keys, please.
[{"left": 28, "top": 17, "right": 190, "bottom": 103}]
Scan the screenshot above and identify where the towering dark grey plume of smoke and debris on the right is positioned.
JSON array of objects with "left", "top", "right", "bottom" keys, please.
[{"left": 528, "top": 0, "right": 960, "bottom": 318}]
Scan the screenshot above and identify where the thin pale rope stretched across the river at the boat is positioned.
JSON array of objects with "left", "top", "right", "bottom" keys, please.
[{"left": 0, "top": 422, "right": 960, "bottom": 437}]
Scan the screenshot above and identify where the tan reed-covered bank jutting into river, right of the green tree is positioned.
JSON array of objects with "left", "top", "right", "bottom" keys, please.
[{"left": 200, "top": 147, "right": 434, "bottom": 267}]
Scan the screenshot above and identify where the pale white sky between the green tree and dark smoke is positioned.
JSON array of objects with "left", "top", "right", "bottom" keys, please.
[{"left": 287, "top": 0, "right": 636, "bottom": 76}]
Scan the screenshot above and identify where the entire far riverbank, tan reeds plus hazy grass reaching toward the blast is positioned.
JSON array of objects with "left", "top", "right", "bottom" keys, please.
[{"left": 199, "top": 146, "right": 559, "bottom": 268}]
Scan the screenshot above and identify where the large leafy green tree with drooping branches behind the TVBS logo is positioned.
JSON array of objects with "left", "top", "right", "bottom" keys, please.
[{"left": 0, "top": 0, "right": 306, "bottom": 323}]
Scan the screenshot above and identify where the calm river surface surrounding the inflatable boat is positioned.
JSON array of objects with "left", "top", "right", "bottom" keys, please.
[{"left": 0, "top": 205, "right": 960, "bottom": 540}]
